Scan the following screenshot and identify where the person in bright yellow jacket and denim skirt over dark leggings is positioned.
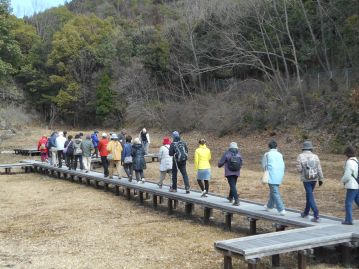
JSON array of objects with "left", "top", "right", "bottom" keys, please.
[{"left": 194, "top": 138, "right": 212, "bottom": 197}]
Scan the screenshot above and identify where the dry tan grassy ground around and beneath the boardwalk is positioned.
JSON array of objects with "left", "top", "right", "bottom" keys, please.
[{"left": 0, "top": 128, "right": 359, "bottom": 268}]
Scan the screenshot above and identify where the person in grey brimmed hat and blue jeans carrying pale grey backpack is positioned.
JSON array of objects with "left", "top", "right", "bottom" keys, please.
[{"left": 297, "top": 140, "right": 324, "bottom": 222}]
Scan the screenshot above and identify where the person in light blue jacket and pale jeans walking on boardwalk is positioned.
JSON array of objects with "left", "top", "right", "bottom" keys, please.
[{"left": 262, "top": 140, "right": 286, "bottom": 216}]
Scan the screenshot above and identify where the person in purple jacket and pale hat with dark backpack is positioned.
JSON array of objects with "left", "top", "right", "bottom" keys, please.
[{"left": 218, "top": 142, "right": 243, "bottom": 206}]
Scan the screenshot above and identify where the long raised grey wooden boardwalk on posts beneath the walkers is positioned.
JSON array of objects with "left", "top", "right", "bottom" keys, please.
[{"left": 5, "top": 161, "right": 359, "bottom": 269}]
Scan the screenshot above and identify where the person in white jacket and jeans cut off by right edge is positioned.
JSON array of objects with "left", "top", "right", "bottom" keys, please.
[{"left": 341, "top": 146, "right": 359, "bottom": 225}]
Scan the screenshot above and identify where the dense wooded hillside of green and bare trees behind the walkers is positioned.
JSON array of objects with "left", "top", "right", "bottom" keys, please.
[{"left": 0, "top": 0, "right": 359, "bottom": 148}]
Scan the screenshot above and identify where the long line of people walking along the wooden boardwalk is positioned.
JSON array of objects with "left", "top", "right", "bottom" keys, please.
[{"left": 38, "top": 128, "right": 359, "bottom": 225}]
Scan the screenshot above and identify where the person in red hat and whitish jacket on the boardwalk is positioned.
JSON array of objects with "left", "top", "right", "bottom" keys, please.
[{"left": 157, "top": 136, "right": 173, "bottom": 188}]
